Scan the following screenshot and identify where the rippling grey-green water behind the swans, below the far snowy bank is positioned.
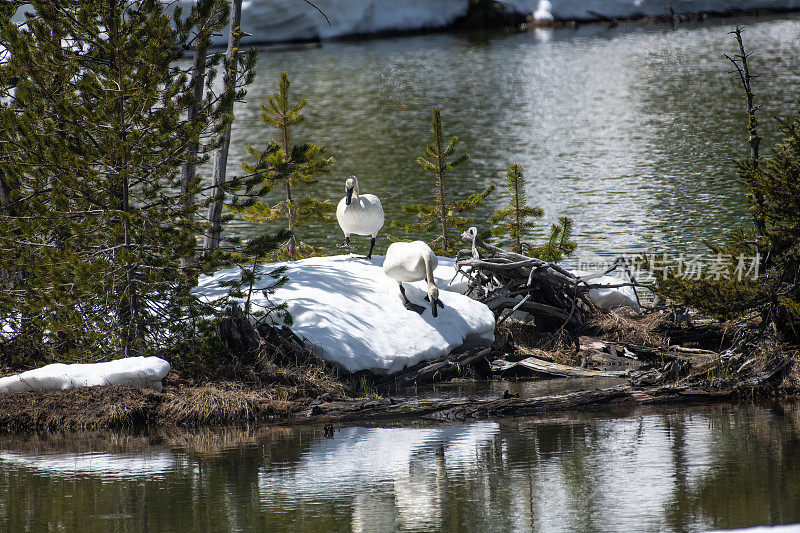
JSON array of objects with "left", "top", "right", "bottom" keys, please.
[{"left": 219, "top": 11, "right": 800, "bottom": 262}]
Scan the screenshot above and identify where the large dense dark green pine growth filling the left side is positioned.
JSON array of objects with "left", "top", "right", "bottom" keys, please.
[{"left": 0, "top": 0, "right": 253, "bottom": 360}]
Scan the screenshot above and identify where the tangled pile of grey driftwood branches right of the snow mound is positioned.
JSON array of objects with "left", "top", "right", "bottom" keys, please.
[{"left": 456, "top": 227, "right": 638, "bottom": 347}]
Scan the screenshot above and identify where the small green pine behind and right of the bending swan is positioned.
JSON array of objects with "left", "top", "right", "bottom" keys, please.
[{"left": 392, "top": 107, "right": 495, "bottom": 254}]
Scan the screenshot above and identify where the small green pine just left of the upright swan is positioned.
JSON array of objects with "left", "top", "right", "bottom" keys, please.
[{"left": 238, "top": 72, "right": 334, "bottom": 261}]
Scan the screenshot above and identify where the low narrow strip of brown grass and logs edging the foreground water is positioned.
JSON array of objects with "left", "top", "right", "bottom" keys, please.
[{"left": 0, "top": 358, "right": 798, "bottom": 433}]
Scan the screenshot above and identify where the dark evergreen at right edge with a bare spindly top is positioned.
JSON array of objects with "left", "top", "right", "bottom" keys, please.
[{"left": 657, "top": 31, "right": 800, "bottom": 341}]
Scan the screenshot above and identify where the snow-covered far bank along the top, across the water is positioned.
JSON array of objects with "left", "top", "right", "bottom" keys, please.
[{"left": 183, "top": 0, "right": 800, "bottom": 43}]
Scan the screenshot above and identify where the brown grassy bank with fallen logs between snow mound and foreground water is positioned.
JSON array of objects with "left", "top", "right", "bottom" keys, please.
[{"left": 0, "top": 313, "right": 800, "bottom": 432}]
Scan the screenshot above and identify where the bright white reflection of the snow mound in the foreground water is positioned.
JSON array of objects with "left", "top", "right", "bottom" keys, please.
[{"left": 259, "top": 422, "right": 498, "bottom": 530}]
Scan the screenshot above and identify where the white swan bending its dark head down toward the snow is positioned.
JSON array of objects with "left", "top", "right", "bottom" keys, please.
[{"left": 383, "top": 241, "right": 444, "bottom": 317}]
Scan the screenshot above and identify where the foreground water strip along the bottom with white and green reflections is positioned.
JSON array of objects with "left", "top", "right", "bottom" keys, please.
[{"left": 0, "top": 404, "right": 800, "bottom": 531}]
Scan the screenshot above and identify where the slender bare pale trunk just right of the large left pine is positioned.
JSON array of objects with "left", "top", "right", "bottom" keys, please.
[{"left": 203, "top": 0, "right": 242, "bottom": 254}]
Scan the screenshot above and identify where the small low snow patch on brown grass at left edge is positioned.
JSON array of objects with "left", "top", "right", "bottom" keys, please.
[{"left": 0, "top": 357, "right": 169, "bottom": 392}]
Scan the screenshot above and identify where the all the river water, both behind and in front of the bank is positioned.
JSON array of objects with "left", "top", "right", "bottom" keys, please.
[{"left": 0, "top": 12, "right": 800, "bottom": 532}]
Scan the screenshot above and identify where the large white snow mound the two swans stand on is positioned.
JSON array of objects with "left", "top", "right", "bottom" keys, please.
[{"left": 195, "top": 255, "right": 494, "bottom": 374}]
